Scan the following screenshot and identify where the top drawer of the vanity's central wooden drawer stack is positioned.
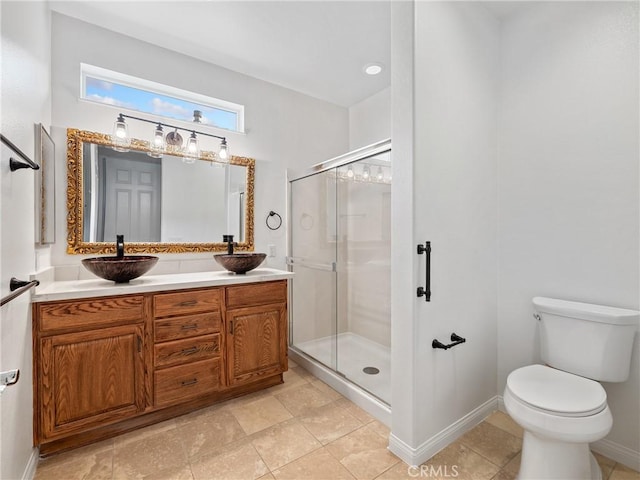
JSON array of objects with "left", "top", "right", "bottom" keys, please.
[{"left": 153, "top": 288, "right": 221, "bottom": 317}]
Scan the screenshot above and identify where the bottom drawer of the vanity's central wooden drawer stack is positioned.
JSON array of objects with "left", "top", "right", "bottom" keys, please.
[{"left": 154, "top": 358, "right": 220, "bottom": 407}]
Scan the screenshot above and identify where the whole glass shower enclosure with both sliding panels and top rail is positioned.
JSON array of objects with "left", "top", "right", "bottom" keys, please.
[{"left": 287, "top": 141, "right": 391, "bottom": 405}]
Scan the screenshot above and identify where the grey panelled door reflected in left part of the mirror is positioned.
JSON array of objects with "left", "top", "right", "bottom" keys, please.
[{"left": 84, "top": 144, "right": 162, "bottom": 242}]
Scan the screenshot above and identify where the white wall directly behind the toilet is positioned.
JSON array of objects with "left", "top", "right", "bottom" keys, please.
[{"left": 498, "top": 2, "right": 640, "bottom": 462}]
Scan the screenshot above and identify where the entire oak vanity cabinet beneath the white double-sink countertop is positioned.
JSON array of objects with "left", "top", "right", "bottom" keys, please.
[{"left": 33, "top": 280, "right": 287, "bottom": 456}]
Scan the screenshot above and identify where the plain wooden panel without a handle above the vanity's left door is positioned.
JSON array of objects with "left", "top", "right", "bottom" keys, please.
[{"left": 36, "top": 295, "right": 144, "bottom": 333}]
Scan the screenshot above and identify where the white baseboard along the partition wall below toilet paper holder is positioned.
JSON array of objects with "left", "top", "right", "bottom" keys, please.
[{"left": 389, "top": 396, "right": 498, "bottom": 466}]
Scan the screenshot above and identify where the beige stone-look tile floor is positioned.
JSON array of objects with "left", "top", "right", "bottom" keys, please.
[{"left": 35, "top": 362, "right": 640, "bottom": 480}]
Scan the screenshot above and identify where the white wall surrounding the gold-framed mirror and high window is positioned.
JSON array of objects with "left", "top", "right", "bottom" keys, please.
[{"left": 52, "top": 13, "right": 349, "bottom": 271}]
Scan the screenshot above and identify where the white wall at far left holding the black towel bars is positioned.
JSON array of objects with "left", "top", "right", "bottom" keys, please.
[{"left": 0, "top": 2, "right": 51, "bottom": 479}]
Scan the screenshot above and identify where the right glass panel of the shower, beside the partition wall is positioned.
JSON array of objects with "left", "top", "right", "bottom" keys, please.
[{"left": 336, "top": 152, "right": 391, "bottom": 404}]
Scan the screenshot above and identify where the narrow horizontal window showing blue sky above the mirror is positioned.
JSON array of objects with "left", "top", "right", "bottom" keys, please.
[{"left": 80, "top": 63, "right": 244, "bottom": 132}]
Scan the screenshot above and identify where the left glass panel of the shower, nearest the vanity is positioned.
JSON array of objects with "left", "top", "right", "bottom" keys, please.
[{"left": 288, "top": 172, "right": 337, "bottom": 370}]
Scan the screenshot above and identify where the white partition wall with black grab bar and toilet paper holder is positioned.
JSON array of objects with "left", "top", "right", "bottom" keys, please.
[{"left": 391, "top": 2, "right": 499, "bottom": 463}]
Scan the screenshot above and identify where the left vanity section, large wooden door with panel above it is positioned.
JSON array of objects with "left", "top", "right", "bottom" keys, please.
[{"left": 33, "top": 295, "right": 145, "bottom": 441}]
